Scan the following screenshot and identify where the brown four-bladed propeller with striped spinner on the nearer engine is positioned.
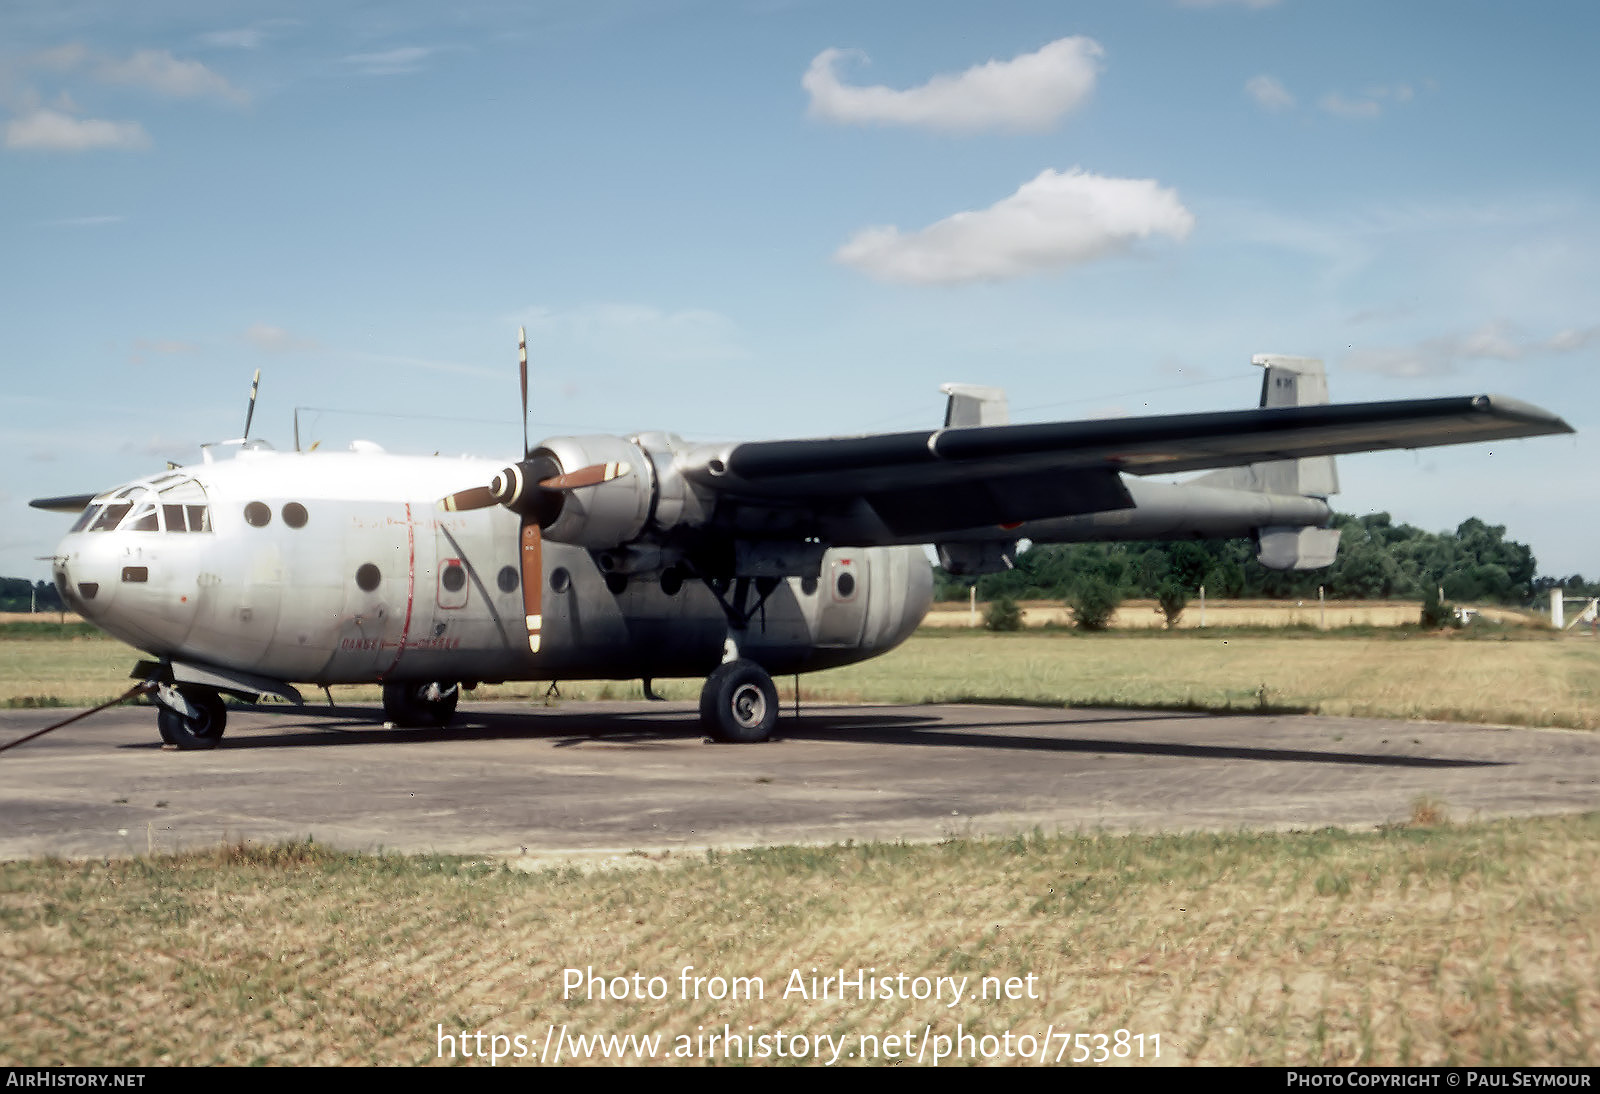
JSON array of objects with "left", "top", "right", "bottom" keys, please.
[{"left": 438, "top": 328, "right": 632, "bottom": 654}]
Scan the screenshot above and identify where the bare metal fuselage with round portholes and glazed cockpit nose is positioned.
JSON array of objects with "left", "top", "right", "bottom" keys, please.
[{"left": 54, "top": 449, "right": 931, "bottom": 685}]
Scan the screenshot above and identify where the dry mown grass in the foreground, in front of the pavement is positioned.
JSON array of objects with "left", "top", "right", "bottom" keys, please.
[{"left": 0, "top": 805, "right": 1600, "bottom": 1065}]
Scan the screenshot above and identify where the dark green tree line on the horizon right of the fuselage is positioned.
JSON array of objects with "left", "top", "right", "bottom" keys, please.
[{"left": 934, "top": 513, "right": 1600, "bottom": 605}]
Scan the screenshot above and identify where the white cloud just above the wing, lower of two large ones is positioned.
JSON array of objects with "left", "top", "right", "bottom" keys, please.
[{"left": 834, "top": 170, "right": 1195, "bottom": 285}]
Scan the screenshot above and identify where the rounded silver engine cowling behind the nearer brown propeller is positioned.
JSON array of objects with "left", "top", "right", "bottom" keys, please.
[{"left": 523, "top": 435, "right": 656, "bottom": 550}]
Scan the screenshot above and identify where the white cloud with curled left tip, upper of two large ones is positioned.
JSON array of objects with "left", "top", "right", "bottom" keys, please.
[{"left": 800, "top": 37, "right": 1104, "bottom": 131}]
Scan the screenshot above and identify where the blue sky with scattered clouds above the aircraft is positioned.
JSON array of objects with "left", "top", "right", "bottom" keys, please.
[{"left": 0, "top": 0, "right": 1600, "bottom": 577}]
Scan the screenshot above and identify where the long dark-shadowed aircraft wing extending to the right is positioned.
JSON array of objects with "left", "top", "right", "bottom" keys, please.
[{"left": 683, "top": 395, "right": 1573, "bottom": 536}]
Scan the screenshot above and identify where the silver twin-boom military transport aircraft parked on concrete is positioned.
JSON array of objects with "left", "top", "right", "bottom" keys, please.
[{"left": 32, "top": 335, "right": 1571, "bottom": 749}]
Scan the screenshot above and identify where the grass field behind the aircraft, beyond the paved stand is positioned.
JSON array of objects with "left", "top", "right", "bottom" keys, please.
[{"left": 0, "top": 610, "right": 1600, "bottom": 729}]
